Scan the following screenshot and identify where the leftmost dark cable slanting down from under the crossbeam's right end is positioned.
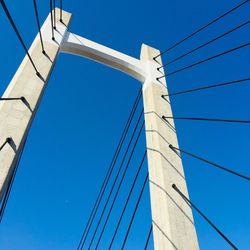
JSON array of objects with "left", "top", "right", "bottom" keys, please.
[{"left": 77, "top": 89, "right": 142, "bottom": 250}]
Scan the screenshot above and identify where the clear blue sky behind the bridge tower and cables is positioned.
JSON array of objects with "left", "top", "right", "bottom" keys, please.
[{"left": 0, "top": 0, "right": 250, "bottom": 250}]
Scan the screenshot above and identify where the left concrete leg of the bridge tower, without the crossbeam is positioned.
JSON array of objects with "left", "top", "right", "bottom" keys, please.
[{"left": 0, "top": 9, "right": 71, "bottom": 201}]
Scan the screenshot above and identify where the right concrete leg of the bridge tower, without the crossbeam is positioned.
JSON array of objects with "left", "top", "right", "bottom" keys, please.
[{"left": 141, "top": 45, "right": 199, "bottom": 250}]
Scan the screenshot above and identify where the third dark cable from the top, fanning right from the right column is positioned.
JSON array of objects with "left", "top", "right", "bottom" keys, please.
[{"left": 157, "top": 42, "right": 250, "bottom": 80}]
